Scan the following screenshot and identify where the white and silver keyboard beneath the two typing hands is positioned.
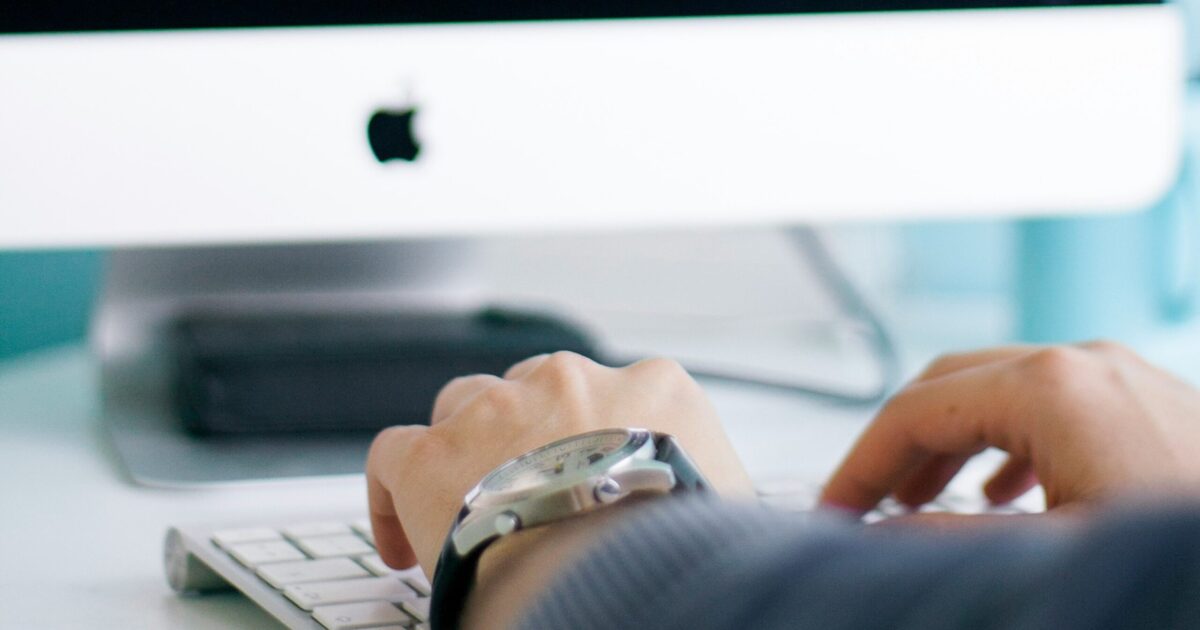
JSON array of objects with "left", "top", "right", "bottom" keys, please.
[{"left": 164, "top": 479, "right": 1042, "bottom": 630}]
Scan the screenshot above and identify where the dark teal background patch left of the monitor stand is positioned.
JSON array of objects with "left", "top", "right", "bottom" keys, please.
[{"left": 0, "top": 251, "right": 104, "bottom": 359}]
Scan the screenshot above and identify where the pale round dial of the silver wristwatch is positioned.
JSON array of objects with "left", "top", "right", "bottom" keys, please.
[{"left": 480, "top": 430, "right": 644, "bottom": 494}]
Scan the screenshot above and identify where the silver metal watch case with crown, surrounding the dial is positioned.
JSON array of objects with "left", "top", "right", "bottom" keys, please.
[{"left": 451, "top": 428, "right": 676, "bottom": 556}]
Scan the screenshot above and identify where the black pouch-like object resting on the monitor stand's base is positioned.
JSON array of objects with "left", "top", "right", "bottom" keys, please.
[{"left": 173, "top": 310, "right": 595, "bottom": 434}]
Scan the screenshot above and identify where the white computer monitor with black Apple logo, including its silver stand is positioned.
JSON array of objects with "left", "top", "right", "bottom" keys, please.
[{"left": 0, "top": 0, "right": 1184, "bottom": 484}]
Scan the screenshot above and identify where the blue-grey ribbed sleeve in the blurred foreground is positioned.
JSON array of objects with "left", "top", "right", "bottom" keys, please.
[{"left": 521, "top": 500, "right": 1200, "bottom": 630}]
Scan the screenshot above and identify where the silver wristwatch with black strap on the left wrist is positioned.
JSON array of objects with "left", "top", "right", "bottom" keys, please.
[{"left": 430, "top": 428, "right": 709, "bottom": 630}]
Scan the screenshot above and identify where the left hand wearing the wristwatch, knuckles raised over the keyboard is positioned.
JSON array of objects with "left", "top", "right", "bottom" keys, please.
[{"left": 367, "top": 353, "right": 752, "bottom": 619}]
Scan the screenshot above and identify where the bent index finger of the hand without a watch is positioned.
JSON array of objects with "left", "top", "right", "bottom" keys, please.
[{"left": 821, "top": 360, "right": 1024, "bottom": 510}]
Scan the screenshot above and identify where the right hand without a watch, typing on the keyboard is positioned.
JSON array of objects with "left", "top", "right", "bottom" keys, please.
[{"left": 821, "top": 342, "right": 1200, "bottom": 511}]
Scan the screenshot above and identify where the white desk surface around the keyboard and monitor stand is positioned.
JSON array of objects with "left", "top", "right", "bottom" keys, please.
[{"left": 0, "top": 347, "right": 883, "bottom": 629}]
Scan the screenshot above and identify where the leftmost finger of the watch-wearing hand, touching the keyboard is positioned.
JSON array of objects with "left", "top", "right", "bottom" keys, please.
[{"left": 366, "top": 426, "right": 425, "bottom": 569}]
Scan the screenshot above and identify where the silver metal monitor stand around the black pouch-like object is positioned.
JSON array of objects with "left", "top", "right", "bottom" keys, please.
[{"left": 91, "top": 241, "right": 479, "bottom": 487}]
